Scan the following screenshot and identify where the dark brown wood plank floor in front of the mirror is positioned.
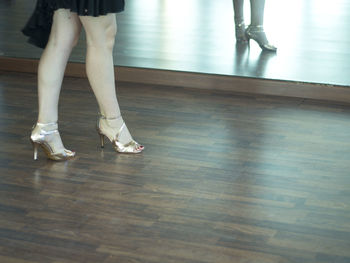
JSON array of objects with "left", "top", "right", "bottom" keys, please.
[{"left": 0, "top": 72, "right": 350, "bottom": 263}]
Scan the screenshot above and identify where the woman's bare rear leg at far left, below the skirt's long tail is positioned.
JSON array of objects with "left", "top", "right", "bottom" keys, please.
[{"left": 31, "top": 9, "right": 81, "bottom": 153}]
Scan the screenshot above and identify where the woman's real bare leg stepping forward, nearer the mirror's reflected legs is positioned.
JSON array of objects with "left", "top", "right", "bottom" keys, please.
[{"left": 80, "top": 14, "right": 141, "bottom": 148}]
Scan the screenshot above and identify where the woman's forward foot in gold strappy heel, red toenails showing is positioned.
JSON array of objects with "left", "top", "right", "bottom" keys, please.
[{"left": 97, "top": 115, "right": 145, "bottom": 153}]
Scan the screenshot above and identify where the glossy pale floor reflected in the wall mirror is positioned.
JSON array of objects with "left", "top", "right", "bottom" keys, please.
[{"left": 0, "top": 0, "right": 350, "bottom": 86}]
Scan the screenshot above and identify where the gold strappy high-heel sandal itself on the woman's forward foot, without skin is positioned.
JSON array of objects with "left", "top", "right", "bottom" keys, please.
[{"left": 96, "top": 115, "right": 145, "bottom": 153}]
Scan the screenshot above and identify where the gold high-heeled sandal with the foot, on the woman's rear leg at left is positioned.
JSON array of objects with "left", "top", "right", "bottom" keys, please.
[{"left": 30, "top": 122, "right": 75, "bottom": 161}]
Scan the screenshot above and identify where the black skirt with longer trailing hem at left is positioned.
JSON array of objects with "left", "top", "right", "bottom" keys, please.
[{"left": 22, "top": 0, "right": 125, "bottom": 48}]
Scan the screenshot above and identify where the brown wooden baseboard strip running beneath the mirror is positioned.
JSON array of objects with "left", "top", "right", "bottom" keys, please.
[{"left": 0, "top": 56, "right": 350, "bottom": 103}]
